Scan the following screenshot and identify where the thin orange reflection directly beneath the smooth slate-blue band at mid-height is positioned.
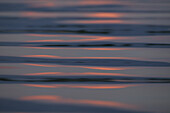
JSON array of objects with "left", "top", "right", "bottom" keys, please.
[{"left": 23, "top": 63, "right": 136, "bottom": 70}]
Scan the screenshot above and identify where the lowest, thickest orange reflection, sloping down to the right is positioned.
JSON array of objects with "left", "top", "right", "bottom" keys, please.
[{"left": 20, "top": 95, "right": 137, "bottom": 109}]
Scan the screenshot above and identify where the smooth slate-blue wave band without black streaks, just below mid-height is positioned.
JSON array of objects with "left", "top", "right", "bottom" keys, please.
[{"left": 0, "top": 56, "right": 170, "bottom": 67}]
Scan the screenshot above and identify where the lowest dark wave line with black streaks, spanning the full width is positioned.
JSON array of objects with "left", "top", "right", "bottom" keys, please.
[{"left": 0, "top": 77, "right": 170, "bottom": 84}]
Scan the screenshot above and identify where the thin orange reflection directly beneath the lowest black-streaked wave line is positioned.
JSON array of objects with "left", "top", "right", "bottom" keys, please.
[{"left": 24, "top": 84, "right": 138, "bottom": 89}]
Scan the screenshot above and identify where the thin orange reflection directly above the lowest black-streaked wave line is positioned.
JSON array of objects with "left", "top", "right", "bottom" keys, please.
[{"left": 24, "top": 72, "right": 129, "bottom": 76}]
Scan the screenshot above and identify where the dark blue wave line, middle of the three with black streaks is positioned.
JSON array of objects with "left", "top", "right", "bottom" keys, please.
[{"left": 0, "top": 40, "right": 170, "bottom": 48}]
